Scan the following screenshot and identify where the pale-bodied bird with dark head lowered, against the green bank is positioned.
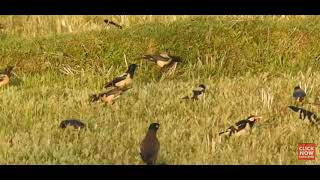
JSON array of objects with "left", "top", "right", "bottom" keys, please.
[{"left": 142, "top": 53, "right": 182, "bottom": 68}]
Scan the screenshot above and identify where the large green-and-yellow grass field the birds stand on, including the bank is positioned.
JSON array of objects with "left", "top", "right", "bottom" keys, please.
[{"left": 0, "top": 16, "right": 320, "bottom": 164}]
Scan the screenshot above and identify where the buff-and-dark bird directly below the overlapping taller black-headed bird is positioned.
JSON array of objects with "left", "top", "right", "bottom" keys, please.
[{"left": 90, "top": 88, "right": 130, "bottom": 105}]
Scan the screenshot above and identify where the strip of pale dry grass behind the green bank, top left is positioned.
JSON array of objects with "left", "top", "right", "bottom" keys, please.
[{"left": 0, "top": 15, "right": 190, "bottom": 37}]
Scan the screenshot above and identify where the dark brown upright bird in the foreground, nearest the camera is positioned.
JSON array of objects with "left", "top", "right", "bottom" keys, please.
[{"left": 140, "top": 123, "right": 160, "bottom": 165}]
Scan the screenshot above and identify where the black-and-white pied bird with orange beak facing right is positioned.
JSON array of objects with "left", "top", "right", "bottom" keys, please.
[{"left": 219, "top": 115, "right": 262, "bottom": 137}]
